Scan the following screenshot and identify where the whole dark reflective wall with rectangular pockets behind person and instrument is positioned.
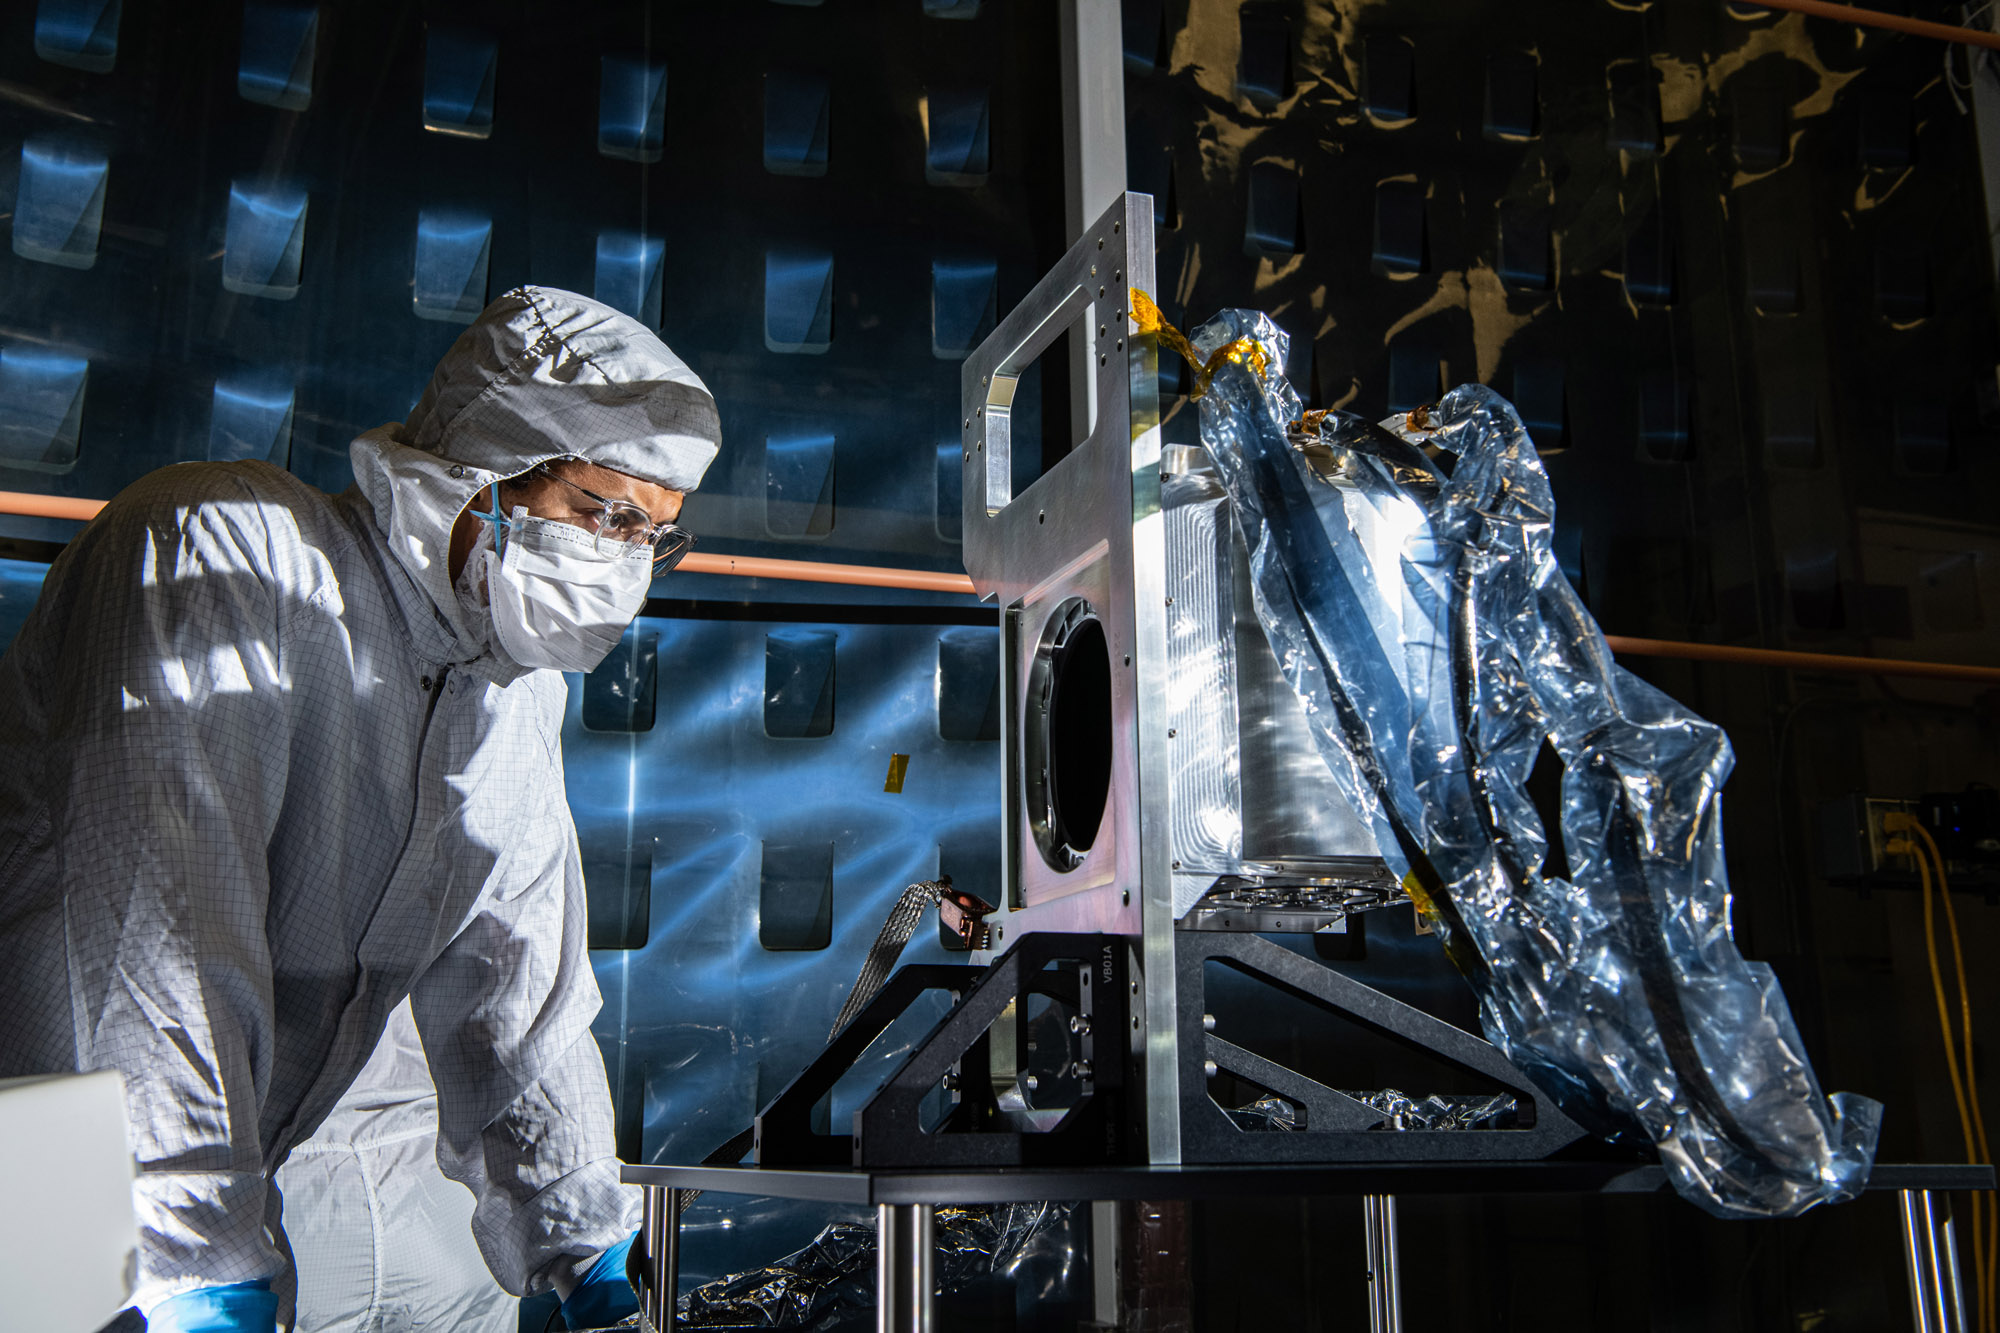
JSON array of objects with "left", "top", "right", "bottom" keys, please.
[{"left": 0, "top": 0, "right": 2000, "bottom": 1329}]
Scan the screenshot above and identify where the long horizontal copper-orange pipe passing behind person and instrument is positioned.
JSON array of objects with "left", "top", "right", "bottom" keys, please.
[{"left": 0, "top": 490, "right": 2000, "bottom": 685}]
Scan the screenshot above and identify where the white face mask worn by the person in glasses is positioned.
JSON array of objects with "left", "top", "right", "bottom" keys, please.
[{"left": 476, "top": 508, "right": 652, "bottom": 671}]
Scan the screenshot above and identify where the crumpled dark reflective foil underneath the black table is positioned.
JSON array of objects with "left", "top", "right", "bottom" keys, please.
[{"left": 680, "top": 1203, "right": 1082, "bottom": 1329}]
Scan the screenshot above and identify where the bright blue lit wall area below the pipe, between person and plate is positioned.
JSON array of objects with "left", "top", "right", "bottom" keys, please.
[{"left": 564, "top": 616, "right": 1000, "bottom": 1176}]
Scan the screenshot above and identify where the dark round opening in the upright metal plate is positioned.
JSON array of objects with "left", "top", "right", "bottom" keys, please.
[{"left": 1026, "top": 598, "right": 1112, "bottom": 871}]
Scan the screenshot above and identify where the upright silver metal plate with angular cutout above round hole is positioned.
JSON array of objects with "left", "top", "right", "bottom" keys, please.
[{"left": 960, "top": 189, "right": 1180, "bottom": 1163}]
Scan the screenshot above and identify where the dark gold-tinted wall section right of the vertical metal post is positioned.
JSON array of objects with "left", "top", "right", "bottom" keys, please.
[{"left": 1124, "top": 0, "right": 2000, "bottom": 1329}]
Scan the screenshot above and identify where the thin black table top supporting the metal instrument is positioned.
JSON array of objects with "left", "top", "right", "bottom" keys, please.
[{"left": 624, "top": 1161, "right": 1994, "bottom": 1205}]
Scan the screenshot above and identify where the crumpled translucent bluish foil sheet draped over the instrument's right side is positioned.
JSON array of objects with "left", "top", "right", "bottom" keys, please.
[{"left": 1194, "top": 310, "right": 1882, "bottom": 1217}]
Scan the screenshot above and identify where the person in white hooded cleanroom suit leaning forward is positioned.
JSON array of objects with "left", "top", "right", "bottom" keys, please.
[{"left": 0, "top": 288, "right": 718, "bottom": 1333}]
